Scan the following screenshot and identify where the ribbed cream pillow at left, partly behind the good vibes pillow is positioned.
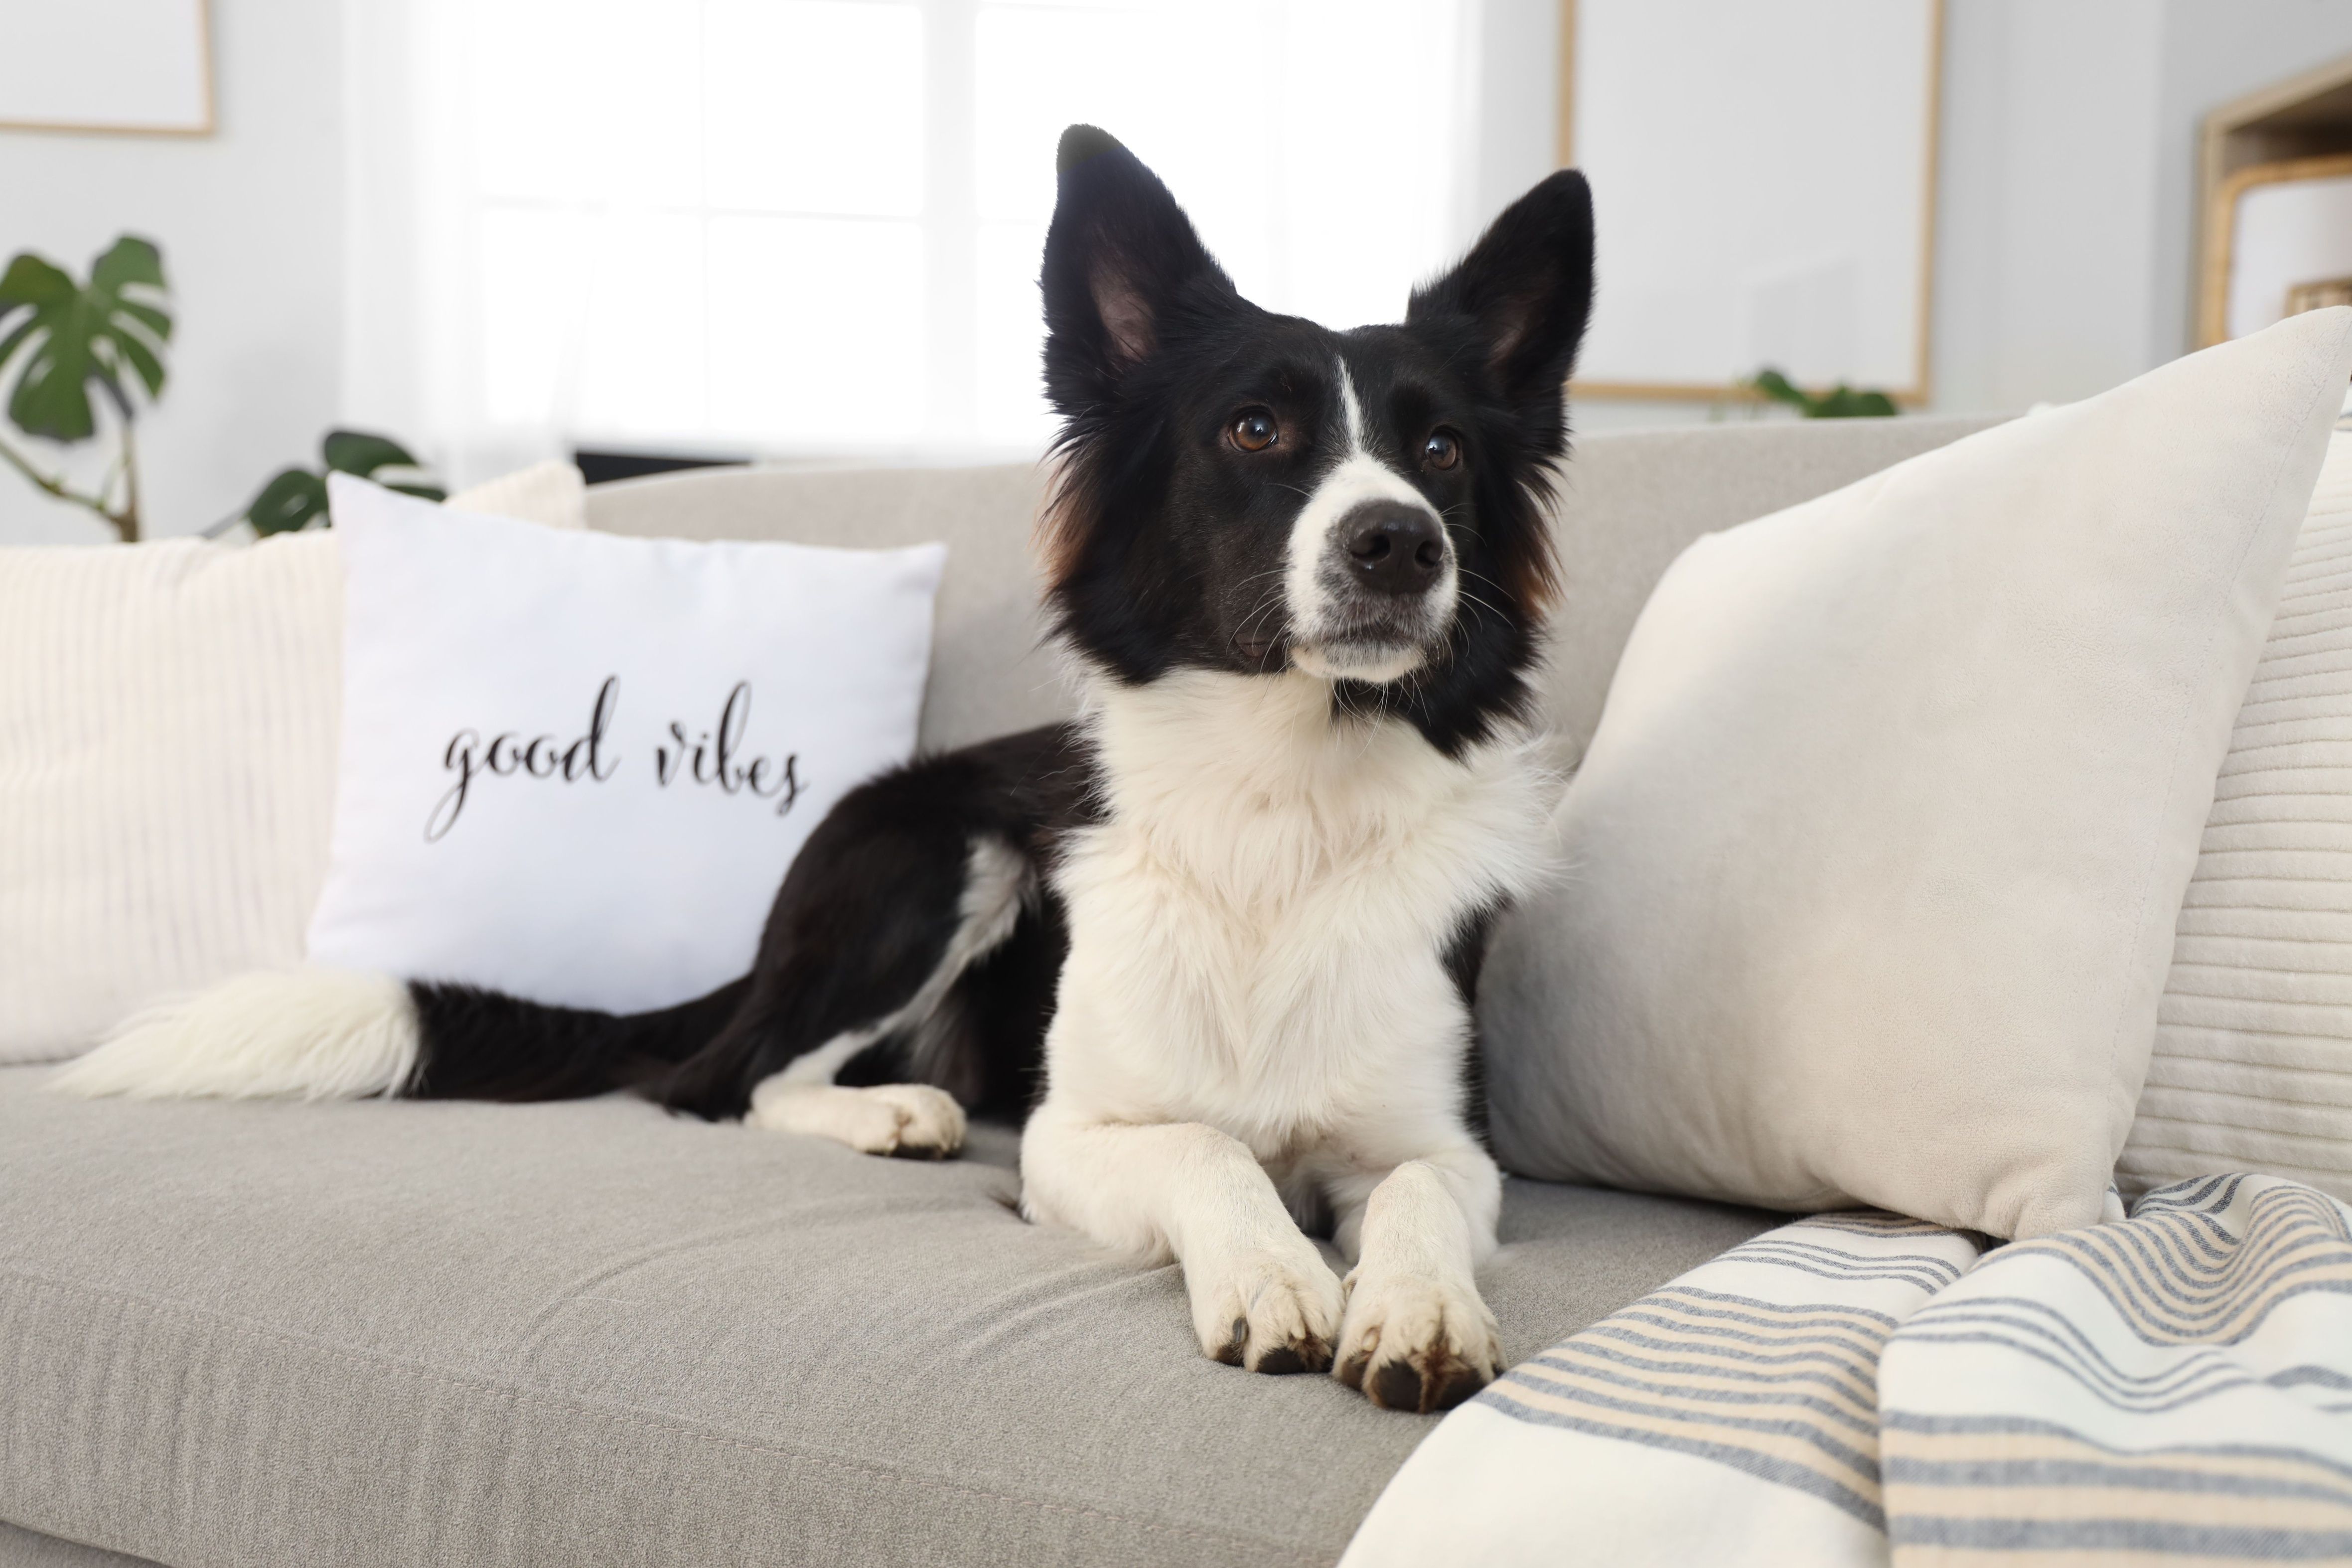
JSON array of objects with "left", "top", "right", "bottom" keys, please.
[{"left": 0, "top": 463, "right": 588, "bottom": 1063}]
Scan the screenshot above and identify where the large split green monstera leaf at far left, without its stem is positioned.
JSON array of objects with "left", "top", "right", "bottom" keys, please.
[{"left": 0, "top": 235, "right": 172, "bottom": 442}]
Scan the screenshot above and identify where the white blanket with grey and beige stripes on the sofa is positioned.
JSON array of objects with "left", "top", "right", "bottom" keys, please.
[{"left": 1343, "top": 1175, "right": 2352, "bottom": 1568}]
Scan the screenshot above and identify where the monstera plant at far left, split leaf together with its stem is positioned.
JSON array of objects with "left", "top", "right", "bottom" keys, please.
[{"left": 0, "top": 235, "right": 172, "bottom": 543}]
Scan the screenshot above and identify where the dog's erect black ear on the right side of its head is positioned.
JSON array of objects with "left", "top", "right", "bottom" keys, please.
[{"left": 1404, "top": 169, "right": 1592, "bottom": 409}]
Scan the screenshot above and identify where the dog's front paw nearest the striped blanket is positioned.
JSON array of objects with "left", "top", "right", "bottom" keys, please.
[{"left": 1331, "top": 1270, "right": 1503, "bottom": 1415}]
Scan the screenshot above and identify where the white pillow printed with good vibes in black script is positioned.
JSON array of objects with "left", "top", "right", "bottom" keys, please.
[{"left": 310, "top": 477, "right": 945, "bottom": 1011}]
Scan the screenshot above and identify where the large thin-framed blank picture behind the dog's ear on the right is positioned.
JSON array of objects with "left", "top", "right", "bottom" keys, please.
[{"left": 1557, "top": 0, "right": 1943, "bottom": 407}]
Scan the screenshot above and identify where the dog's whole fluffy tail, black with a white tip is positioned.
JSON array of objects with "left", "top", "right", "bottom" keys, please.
[{"left": 49, "top": 969, "right": 745, "bottom": 1100}]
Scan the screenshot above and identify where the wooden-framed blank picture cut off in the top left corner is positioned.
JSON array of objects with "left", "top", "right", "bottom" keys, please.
[{"left": 0, "top": 0, "right": 216, "bottom": 137}]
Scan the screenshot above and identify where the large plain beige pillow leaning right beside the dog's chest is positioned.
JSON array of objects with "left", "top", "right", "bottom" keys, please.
[{"left": 1479, "top": 310, "right": 2352, "bottom": 1237}]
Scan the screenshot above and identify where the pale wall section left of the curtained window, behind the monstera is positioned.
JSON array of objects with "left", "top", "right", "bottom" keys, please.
[{"left": 0, "top": 0, "right": 343, "bottom": 543}]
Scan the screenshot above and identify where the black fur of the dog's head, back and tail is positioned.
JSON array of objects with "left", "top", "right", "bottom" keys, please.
[{"left": 405, "top": 127, "right": 1592, "bottom": 1117}]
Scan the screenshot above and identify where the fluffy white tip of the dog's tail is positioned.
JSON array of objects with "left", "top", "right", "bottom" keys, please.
[{"left": 47, "top": 969, "right": 419, "bottom": 1100}]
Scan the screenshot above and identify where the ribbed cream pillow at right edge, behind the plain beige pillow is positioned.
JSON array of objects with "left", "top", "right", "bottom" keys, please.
[{"left": 2117, "top": 430, "right": 2352, "bottom": 1199}]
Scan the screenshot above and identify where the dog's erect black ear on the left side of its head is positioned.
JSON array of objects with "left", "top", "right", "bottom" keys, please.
[{"left": 1044, "top": 125, "right": 1237, "bottom": 414}]
